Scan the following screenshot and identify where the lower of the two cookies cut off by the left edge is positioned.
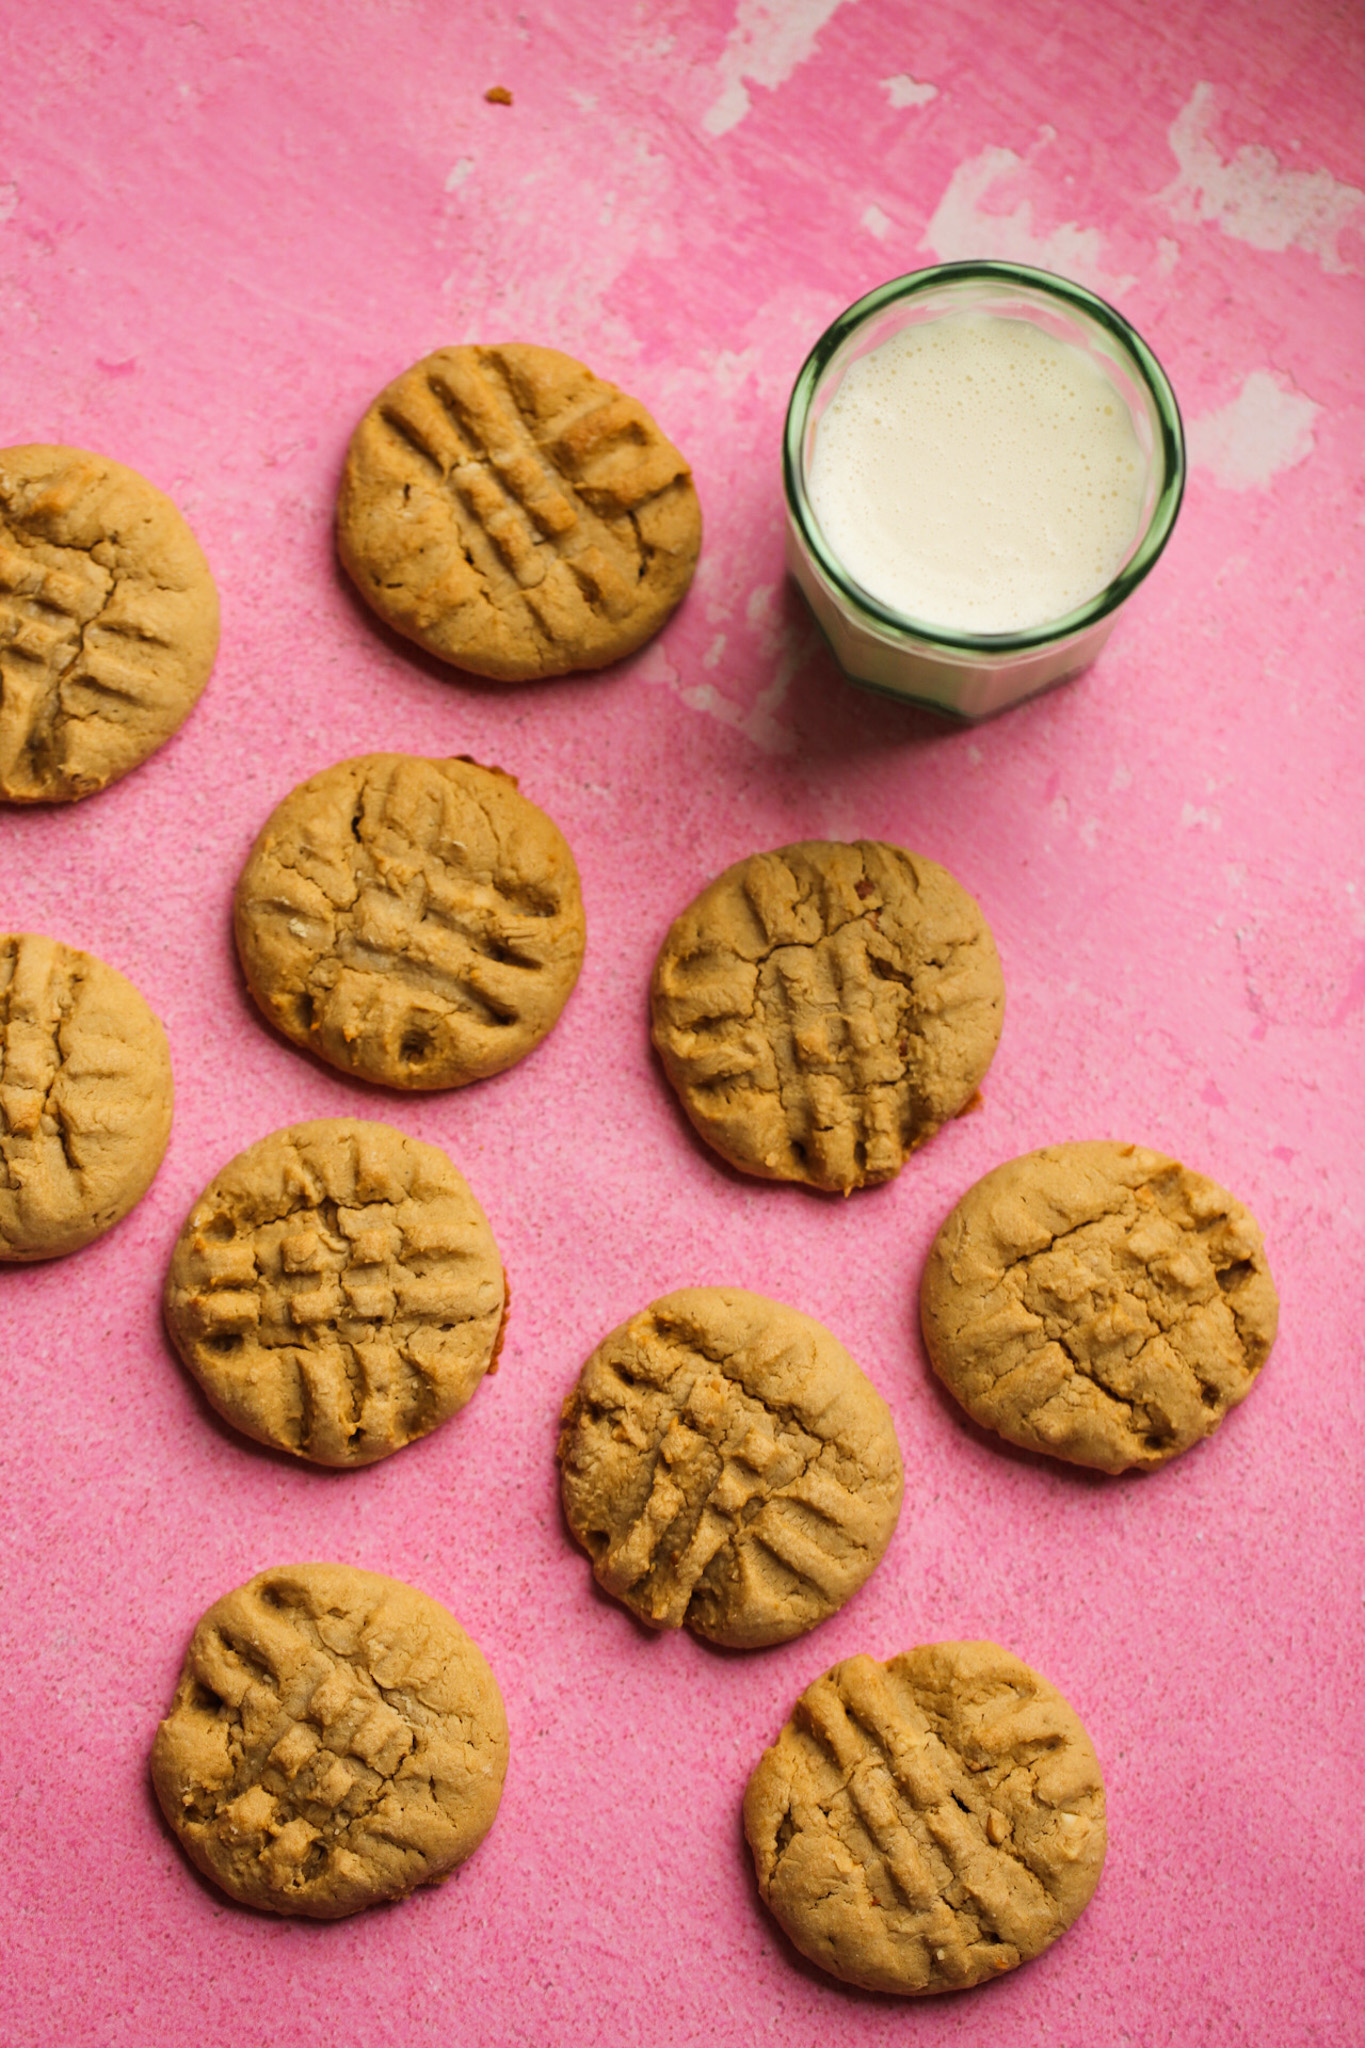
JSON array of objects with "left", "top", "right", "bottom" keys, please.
[{"left": 0, "top": 932, "right": 174, "bottom": 1260}]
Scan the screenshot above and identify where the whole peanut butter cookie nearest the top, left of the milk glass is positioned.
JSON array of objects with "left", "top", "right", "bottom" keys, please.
[{"left": 336, "top": 342, "right": 702, "bottom": 682}]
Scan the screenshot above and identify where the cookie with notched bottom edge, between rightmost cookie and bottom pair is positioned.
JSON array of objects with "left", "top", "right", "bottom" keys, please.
[{"left": 559, "top": 1286, "right": 902, "bottom": 1649}]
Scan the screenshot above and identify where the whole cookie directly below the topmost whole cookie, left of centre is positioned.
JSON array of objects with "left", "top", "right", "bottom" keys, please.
[{"left": 235, "top": 754, "right": 583, "bottom": 1087}]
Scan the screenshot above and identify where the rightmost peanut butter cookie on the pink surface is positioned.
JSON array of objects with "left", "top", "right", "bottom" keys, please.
[{"left": 921, "top": 1143, "right": 1279, "bottom": 1473}]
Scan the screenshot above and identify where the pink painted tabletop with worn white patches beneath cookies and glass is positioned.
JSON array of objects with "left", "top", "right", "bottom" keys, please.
[{"left": 0, "top": 0, "right": 1365, "bottom": 2048}]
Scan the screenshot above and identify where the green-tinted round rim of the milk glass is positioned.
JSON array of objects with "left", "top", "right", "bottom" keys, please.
[{"left": 782, "top": 260, "right": 1185, "bottom": 653}]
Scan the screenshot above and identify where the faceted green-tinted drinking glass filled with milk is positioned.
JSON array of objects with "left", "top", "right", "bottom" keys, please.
[{"left": 784, "top": 262, "right": 1185, "bottom": 719}]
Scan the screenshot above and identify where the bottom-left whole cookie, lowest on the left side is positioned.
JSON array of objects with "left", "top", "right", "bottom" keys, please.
[{"left": 151, "top": 1565, "right": 508, "bottom": 1919}]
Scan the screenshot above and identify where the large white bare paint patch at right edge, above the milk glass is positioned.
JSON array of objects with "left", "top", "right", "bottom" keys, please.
[{"left": 1156, "top": 80, "right": 1365, "bottom": 276}]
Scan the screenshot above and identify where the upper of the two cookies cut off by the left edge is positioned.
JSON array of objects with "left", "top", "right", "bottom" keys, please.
[{"left": 0, "top": 446, "right": 219, "bottom": 803}]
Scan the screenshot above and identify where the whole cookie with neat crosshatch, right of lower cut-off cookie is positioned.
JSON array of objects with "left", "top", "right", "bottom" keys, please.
[{"left": 166, "top": 1118, "right": 508, "bottom": 1466}]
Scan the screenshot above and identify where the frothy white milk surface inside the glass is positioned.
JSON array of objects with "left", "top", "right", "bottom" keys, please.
[{"left": 806, "top": 313, "right": 1146, "bottom": 633}]
